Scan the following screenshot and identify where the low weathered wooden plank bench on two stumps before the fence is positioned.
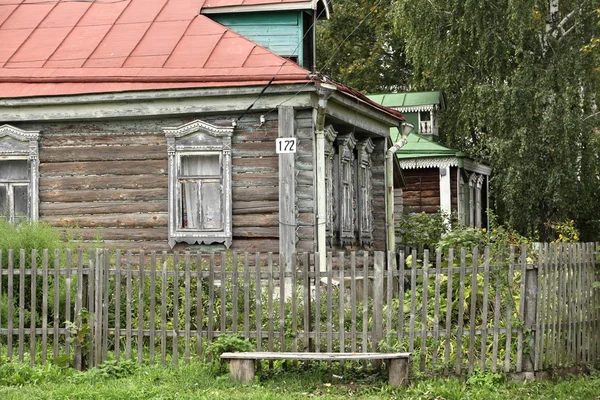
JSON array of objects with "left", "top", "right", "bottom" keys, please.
[{"left": 221, "top": 352, "right": 410, "bottom": 386}]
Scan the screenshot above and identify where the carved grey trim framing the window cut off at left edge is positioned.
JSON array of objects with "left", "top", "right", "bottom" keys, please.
[{"left": 0, "top": 125, "right": 40, "bottom": 223}]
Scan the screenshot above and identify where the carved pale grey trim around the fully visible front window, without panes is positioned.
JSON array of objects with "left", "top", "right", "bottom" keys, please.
[{"left": 163, "top": 120, "right": 233, "bottom": 248}]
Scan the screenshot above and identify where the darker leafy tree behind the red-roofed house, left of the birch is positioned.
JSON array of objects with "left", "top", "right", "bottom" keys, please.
[{"left": 317, "top": 0, "right": 410, "bottom": 93}]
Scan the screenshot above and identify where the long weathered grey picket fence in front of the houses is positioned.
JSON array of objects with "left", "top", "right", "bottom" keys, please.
[{"left": 0, "top": 244, "right": 600, "bottom": 375}]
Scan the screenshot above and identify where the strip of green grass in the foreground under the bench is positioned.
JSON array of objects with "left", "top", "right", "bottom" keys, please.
[{"left": 0, "top": 362, "right": 600, "bottom": 400}]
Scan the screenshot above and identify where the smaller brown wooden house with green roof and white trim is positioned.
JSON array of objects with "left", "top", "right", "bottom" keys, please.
[{"left": 369, "top": 91, "right": 491, "bottom": 228}]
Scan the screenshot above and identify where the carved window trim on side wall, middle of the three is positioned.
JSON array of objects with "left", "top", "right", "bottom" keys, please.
[{"left": 337, "top": 133, "right": 356, "bottom": 246}]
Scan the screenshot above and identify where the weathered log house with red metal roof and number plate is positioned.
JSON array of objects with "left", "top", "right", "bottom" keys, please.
[{"left": 0, "top": 0, "right": 403, "bottom": 255}]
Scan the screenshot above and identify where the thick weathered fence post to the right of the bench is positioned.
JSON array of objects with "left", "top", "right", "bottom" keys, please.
[{"left": 522, "top": 248, "right": 539, "bottom": 380}]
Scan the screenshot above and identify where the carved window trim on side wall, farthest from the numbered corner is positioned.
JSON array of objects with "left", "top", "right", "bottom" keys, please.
[{"left": 357, "top": 138, "right": 375, "bottom": 246}]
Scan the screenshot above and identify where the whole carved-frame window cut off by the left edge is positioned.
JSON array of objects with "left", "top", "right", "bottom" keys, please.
[{"left": 0, "top": 125, "right": 39, "bottom": 223}]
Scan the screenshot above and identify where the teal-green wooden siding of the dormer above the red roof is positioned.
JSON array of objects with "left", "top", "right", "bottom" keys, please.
[{"left": 210, "top": 11, "right": 304, "bottom": 66}]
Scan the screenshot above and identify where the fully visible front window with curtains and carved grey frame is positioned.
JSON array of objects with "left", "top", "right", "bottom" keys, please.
[{"left": 164, "top": 121, "right": 233, "bottom": 247}]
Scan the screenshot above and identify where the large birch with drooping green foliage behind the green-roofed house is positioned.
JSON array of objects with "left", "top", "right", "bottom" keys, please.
[{"left": 395, "top": 0, "right": 600, "bottom": 240}]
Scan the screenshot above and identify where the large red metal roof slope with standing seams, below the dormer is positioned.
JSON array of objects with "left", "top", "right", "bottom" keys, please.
[{"left": 0, "top": 0, "right": 308, "bottom": 98}]
